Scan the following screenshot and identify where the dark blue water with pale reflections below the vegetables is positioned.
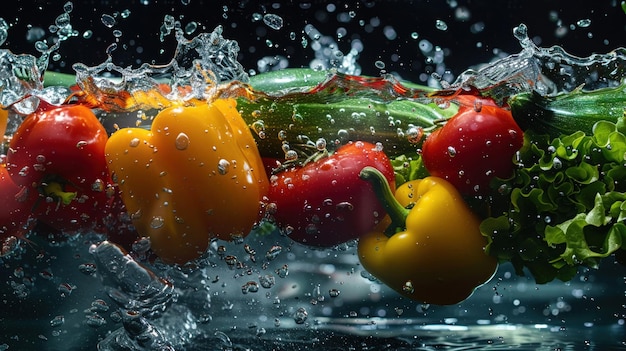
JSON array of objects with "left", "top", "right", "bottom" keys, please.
[{"left": 0, "top": 230, "right": 626, "bottom": 350}]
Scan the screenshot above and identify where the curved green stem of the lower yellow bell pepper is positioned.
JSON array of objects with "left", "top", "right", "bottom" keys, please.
[{"left": 359, "top": 166, "right": 410, "bottom": 235}]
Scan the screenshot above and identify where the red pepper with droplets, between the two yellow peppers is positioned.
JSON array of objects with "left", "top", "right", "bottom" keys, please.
[{"left": 268, "top": 142, "right": 395, "bottom": 247}]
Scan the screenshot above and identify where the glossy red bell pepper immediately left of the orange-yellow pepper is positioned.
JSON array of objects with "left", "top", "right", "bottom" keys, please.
[{"left": 6, "top": 105, "right": 112, "bottom": 231}]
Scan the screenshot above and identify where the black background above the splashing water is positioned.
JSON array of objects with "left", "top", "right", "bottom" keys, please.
[{"left": 0, "top": 0, "right": 626, "bottom": 82}]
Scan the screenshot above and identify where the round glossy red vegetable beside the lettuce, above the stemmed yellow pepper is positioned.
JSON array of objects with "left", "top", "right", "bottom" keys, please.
[{"left": 422, "top": 105, "right": 524, "bottom": 195}]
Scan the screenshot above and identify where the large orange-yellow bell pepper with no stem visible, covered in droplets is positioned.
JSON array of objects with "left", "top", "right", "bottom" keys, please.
[{"left": 105, "top": 99, "right": 269, "bottom": 263}]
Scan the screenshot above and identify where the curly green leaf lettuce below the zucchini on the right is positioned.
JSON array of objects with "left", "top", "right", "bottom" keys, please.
[{"left": 481, "top": 118, "right": 626, "bottom": 283}]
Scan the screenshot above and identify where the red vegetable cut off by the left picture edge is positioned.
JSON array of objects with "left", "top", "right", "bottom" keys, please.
[{"left": 0, "top": 165, "right": 34, "bottom": 246}]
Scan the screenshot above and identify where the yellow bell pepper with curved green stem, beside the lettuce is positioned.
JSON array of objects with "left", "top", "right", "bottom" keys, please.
[{"left": 358, "top": 168, "right": 497, "bottom": 305}]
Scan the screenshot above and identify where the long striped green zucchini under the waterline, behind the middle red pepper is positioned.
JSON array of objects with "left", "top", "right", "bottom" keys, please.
[{"left": 237, "top": 69, "right": 457, "bottom": 157}]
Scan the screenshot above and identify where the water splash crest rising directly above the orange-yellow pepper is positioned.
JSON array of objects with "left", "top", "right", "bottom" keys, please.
[{"left": 73, "top": 26, "right": 248, "bottom": 111}]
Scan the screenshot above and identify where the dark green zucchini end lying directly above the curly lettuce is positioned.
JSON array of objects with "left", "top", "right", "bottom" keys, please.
[{"left": 509, "top": 83, "right": 626, "bottom": 138}]
